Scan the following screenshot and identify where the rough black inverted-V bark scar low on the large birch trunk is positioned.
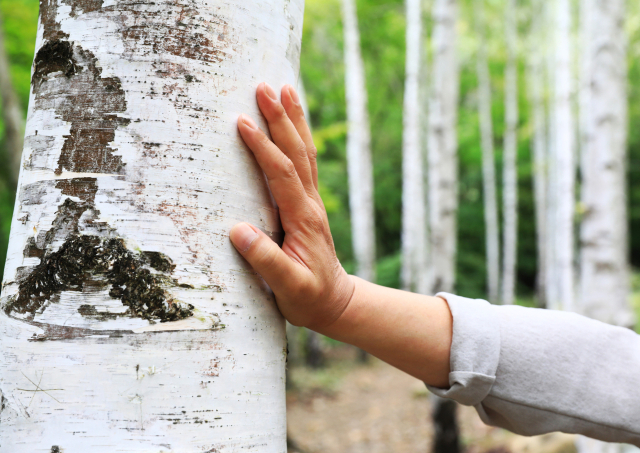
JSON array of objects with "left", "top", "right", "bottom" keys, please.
[{"left": 4, "top": 199, "right": 194, "bottom": 322}]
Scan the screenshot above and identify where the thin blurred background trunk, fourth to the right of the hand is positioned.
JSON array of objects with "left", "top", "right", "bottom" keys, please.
[{"left": 474, "top": 0, "right": 500, "bottom": 303}]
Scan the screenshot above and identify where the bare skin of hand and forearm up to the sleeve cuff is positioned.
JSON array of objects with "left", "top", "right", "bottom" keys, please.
[{"left": 230, "top": 83, "right": 453, "bottom": 388}]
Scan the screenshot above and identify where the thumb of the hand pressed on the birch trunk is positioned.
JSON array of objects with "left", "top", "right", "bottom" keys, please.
[{"left": 229, "top": 223, "right": 296, "bottom": 291}]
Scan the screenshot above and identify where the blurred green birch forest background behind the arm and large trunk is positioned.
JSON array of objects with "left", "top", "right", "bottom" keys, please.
[{"left": 0, "top": 0, "right": 640, "bottom": 452}]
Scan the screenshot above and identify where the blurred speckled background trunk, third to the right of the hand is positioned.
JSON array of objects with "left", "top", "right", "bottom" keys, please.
[{"left": 427, "top": 0, "right": 460, "bottom": 292}]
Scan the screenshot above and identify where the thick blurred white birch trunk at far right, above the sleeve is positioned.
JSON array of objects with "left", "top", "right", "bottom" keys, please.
[{"left": 579, "top": 0, "right": 634, "bottom": 327}]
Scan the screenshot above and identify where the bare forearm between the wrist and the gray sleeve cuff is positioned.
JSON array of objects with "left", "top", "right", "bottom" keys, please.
[{"left": 319, "top": 277, "right": 453, "bottom": 388}]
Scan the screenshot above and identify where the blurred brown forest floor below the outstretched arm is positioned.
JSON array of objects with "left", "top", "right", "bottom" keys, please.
[{"left": 287, "top": 347, "right": 575, "bottom": 453}]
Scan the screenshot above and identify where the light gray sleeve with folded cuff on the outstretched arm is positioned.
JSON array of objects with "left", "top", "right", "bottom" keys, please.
[{"left": 429, "top": 293, "right": 640, "bottom": 447}]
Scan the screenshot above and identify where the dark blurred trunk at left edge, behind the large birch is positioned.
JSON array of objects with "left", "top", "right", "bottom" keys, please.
[{"left": 0, "top": 13, "right": 24, "bottom": 186}]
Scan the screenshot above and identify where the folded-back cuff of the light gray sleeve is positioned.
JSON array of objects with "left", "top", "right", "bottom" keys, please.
[{"left": 427, "top": 293, "right": 500, "bottom": 406}]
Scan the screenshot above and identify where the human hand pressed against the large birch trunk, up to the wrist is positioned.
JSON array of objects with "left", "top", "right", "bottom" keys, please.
[{"left": 230, "top": 83, "right": 355, "bottom": 330}]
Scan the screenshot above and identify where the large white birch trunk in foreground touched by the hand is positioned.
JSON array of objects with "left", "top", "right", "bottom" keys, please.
[{"left": 0, "top": 0, "right": 304, "bottom": 453}]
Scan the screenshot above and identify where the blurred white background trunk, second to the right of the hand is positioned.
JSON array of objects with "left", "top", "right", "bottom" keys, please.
[{"left": 402, "top": 0, "right": 431, "bottom": 294}]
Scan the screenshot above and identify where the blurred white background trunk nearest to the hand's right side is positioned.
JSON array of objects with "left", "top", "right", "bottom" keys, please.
[{"left": 342, "top": 0, "right": 375, "bottom": 282}]
